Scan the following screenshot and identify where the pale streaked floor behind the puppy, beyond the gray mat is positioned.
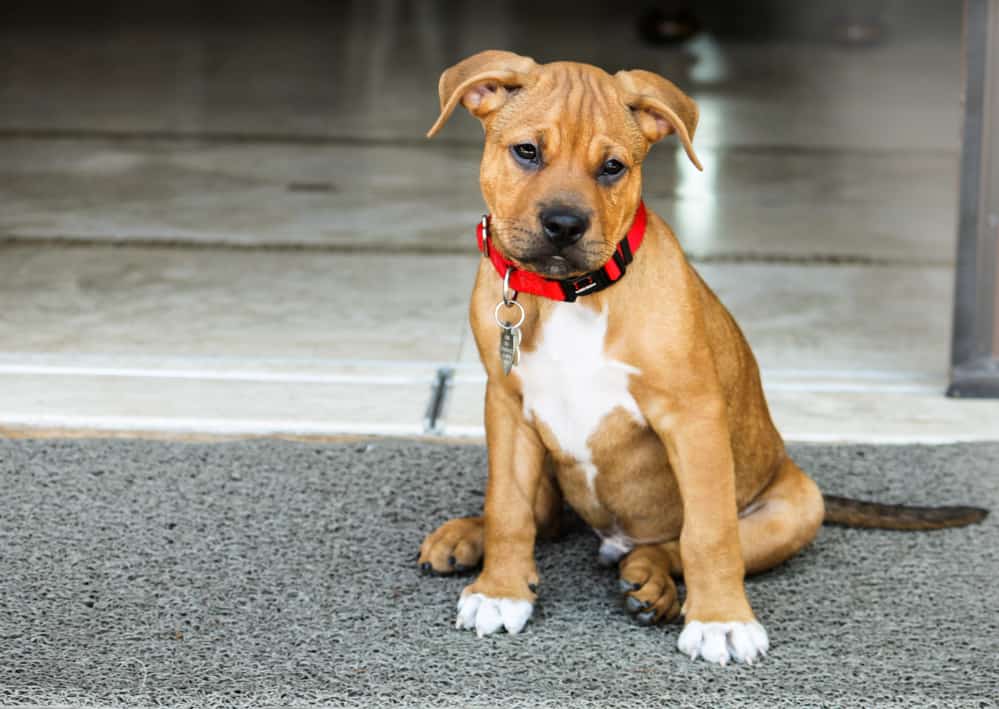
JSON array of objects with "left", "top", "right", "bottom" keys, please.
[{"left": 0, "top": 2, "right": 999, "bottom": 441}]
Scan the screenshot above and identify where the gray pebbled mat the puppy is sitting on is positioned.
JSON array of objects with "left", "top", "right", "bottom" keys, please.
[{"left": 0, "top": 440, "right": 999, "bottom": 709}]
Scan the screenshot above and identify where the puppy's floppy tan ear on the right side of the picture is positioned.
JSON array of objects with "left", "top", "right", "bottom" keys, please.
[{"left": 614, "top": 69, "right": 704, "bottom": 170}]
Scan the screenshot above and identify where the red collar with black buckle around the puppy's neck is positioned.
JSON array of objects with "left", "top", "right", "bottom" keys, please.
[{"left": 476, "top": 202, "right": 645, "bottom": 303}]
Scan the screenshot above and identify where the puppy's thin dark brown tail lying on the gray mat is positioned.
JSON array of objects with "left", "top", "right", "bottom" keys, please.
[{"left": 822, "top": 495, "right": 989, "bottom": 530}]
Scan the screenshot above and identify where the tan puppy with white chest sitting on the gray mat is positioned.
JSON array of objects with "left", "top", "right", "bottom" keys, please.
[{"left": 419, "top": 51, "right": 988, "bottom": 664}]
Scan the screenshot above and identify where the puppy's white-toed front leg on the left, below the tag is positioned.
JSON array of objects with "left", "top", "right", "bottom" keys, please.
[{"left": 455, "top": 381, "right": 545, "bottom": 637}]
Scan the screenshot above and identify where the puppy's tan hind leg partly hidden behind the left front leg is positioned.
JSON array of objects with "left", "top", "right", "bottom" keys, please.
[{"left": 417, "top": 460, "right": 562, "bottom": 574}]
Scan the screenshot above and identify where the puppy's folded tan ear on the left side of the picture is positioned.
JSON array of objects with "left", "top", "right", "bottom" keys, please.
[{"left": 427, "top": 49, "right": 537, "bottom": 138}]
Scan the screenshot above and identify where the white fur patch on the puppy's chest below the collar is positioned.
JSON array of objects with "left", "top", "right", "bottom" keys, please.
[{"left": 514, "top": 303, "right": 642, "bottom": 464}]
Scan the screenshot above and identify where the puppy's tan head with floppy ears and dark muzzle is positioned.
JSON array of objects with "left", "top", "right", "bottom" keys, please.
[{"left": 427, "top": 51, "right": 701, "bottom": 278}]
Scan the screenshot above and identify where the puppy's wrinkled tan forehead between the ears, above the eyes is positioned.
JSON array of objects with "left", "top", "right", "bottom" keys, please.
[{"left": 489, "top": 62, "right": 646, "bottom": 157}]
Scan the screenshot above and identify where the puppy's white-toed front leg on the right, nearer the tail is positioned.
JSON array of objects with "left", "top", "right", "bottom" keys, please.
[{"left": 640, "top": 391, "right": 769, "bottom": 665}]
